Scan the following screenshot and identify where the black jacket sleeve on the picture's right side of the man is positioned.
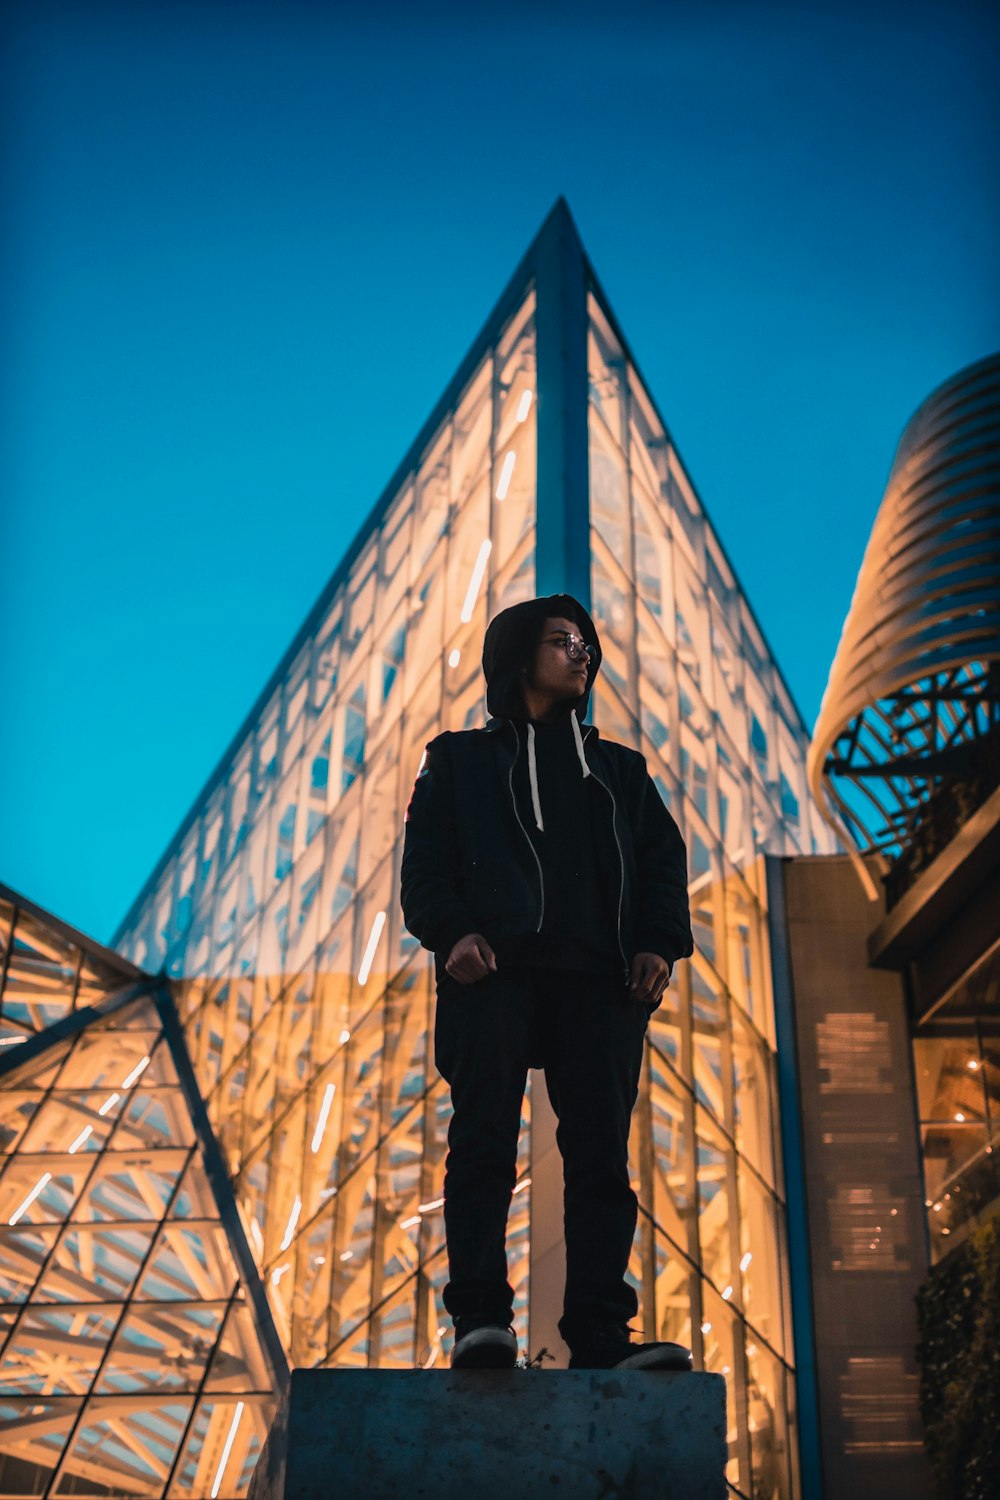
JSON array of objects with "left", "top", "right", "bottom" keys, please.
[{"left": 633, "top": 756, "right": 694, "bottom": 965}]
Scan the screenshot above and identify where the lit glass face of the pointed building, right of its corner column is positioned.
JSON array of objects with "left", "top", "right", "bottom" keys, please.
[{"left": 588, "top": 286, "right": 831, "bottom": 1500}]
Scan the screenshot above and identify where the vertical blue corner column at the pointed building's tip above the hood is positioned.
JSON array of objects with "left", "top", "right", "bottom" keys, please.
[{"left": 535, "top": 198, "right": 591, "bottom": 611}]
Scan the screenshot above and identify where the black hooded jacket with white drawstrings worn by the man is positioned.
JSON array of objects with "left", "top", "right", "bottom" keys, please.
[{"left": 400, "top": 594, "right": 694, "bottom": 983}]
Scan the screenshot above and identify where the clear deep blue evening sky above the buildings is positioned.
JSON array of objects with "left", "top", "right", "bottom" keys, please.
[{"left": 0, "top": 0, "right": 1000, "bottom": 941}]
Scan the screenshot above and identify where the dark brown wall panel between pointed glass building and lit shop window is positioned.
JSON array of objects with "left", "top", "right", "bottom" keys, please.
[{"left": 772, "top": 857, "right": 931, "bottom": 1500}]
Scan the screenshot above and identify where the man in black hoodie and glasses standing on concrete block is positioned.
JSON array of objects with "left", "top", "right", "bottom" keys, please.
[{"left": 400, "top": 594, "right": 693, "bottom": 1370}]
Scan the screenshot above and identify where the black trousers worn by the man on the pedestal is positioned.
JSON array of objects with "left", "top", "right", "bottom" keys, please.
[{"left": 435, "top": 969, "right": 651, "bottom": 1344}]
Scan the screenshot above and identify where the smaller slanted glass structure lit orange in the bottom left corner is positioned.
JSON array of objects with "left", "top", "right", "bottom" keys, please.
[{"left": 0, "top": 902, "right": 285, "bottom": 1500}]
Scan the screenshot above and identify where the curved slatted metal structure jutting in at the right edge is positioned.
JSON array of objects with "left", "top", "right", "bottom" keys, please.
[{"left": 807, "top": 354, "right": 1000, "bottom": 900}]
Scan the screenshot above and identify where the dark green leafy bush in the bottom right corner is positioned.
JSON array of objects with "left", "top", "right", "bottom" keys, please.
[{"left": 916, "top": 1218, "right": 1000, "bottom": 1500}]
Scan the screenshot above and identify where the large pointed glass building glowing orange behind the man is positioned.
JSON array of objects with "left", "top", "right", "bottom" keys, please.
[{"left": 3, "top": 203, "right": 834, "bottom": 1500}]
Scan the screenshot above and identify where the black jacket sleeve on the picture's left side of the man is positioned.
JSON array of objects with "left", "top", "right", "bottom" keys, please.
[{"left": 399, "top": 732, "right": 477, "bottom": 957}]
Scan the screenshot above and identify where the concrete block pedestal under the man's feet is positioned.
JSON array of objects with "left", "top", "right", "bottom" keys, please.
[{"left": 249, "top": 1370, "right": 726, "bottom": 1500}]
